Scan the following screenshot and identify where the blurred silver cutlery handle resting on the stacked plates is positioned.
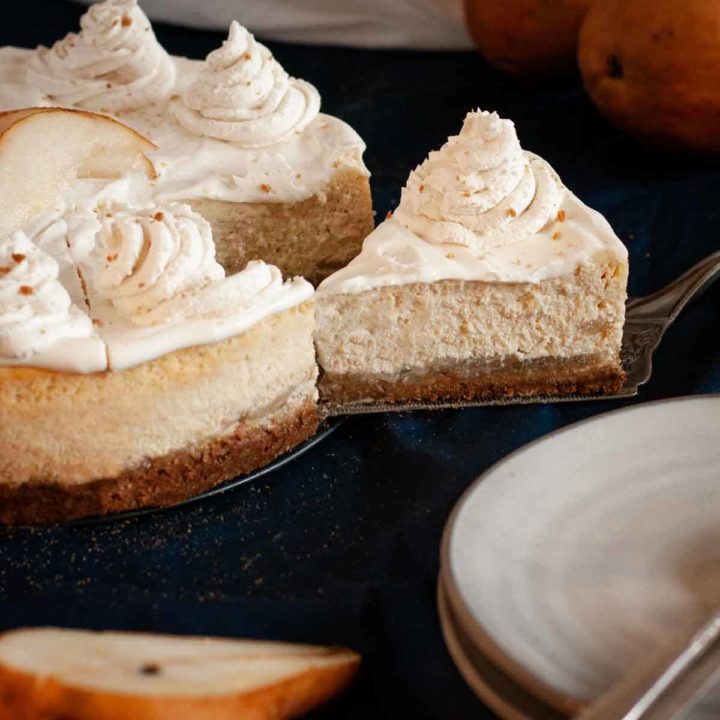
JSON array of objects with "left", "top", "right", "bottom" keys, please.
[{"left": 576, "top": 613, "right": 720, "bottom": 720}]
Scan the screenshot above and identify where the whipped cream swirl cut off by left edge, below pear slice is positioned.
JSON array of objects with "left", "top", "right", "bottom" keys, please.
[{"left": 0, "top": 231, "right": 94, "bottom": 359}]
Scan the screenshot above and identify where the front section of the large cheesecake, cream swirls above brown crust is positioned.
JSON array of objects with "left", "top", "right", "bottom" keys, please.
[{"left": 0, "top": 204, "right": 317, "bottom": 524}]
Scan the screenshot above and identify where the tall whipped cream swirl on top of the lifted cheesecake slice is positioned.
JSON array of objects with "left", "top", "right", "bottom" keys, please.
[{"left": 393, "top": 111, "right": 563, "bottom": 254}]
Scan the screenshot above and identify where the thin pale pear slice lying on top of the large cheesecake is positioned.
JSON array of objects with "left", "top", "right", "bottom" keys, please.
[{"left": 0, "top": 108, "right": 155, "bottom": 237}]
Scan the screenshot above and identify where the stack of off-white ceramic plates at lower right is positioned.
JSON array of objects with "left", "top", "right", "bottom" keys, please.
[{"left": 438, "top": 396, "right": 720, "bottom": 720}]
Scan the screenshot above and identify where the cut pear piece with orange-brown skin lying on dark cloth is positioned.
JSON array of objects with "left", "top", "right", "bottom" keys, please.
[{"left": 0, "top": 628, "right": 360, "bottom": 720}]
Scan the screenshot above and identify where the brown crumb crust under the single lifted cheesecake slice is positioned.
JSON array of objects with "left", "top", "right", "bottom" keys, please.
[{"left": 318, "top": 358, "right": 625, "bottom": 412}]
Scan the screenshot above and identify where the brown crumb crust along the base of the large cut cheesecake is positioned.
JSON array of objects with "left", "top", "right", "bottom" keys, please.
[{"left": 0, "top": 398, "right": 318, "bottom": 525}]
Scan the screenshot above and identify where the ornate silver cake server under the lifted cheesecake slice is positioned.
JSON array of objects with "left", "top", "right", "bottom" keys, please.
[{"left": 324, "top": 251, "right": 720, "bottom": 415}]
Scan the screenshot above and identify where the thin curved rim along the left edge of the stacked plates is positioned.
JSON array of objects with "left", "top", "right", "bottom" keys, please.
[{"left": 440, "top": 393, "right": 720, "bottom": 714}]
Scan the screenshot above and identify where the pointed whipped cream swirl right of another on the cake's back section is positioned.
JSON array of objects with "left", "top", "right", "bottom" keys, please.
[{"left": 173, "top": 21, "right": 320, "bottom": 148}]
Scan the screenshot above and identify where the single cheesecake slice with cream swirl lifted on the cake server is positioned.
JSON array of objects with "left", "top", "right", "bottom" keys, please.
[{"left": 315, "top": 112, "right": 628, "bottom": 406}]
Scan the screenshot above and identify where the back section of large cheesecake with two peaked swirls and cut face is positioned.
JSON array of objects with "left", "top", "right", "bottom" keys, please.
[{"left": 0, "top": 0, "right": 374, "bottom": 283}]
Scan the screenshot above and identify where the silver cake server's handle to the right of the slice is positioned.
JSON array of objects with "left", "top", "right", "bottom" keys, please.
[{"left": 626, "top": 251, "right": 720, "bottom": 325}]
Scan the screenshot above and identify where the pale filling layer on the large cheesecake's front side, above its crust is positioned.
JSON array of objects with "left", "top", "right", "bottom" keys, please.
[{"left": 0, "top": 306, "right": 317, "bottom": 487}]
